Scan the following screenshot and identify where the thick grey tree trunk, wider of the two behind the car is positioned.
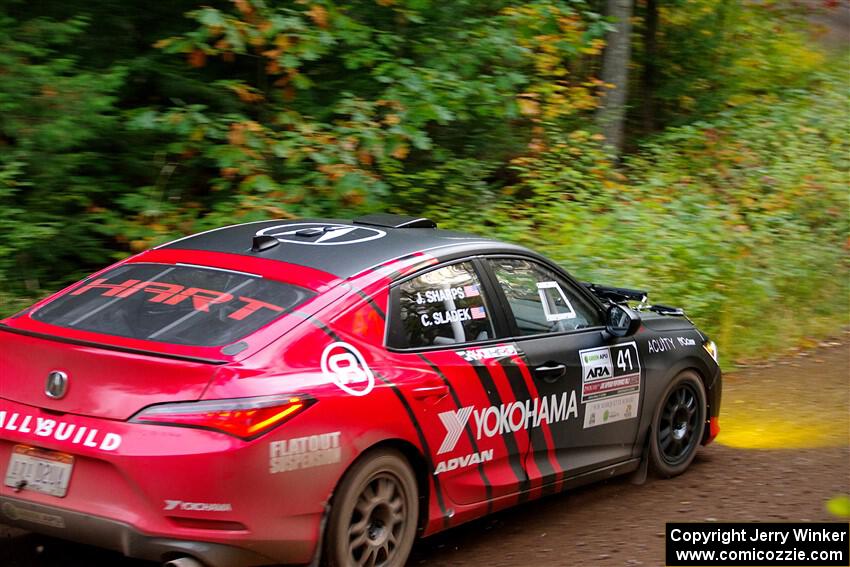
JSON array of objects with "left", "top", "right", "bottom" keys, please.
[{"left": 597, "top": 0, "right": 634, "bottom": 154}]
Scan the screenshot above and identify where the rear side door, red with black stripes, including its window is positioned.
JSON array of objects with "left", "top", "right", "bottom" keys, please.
[{"left": 387, "top": 260, "right": 529, "bottom": 504}]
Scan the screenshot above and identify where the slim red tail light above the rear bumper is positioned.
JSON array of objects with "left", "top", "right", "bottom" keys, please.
[{"left": 130, "top": 396, "right": 315, "bottom": 440}]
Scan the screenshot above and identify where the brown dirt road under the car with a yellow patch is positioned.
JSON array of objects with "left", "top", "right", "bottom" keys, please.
[{"left": 0, "top": 335, "right": 850, "bottom": 567}]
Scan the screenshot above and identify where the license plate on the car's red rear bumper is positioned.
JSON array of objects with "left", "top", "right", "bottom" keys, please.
[{"left": 4, "top": 445, "right": 74, "bottom": 498}]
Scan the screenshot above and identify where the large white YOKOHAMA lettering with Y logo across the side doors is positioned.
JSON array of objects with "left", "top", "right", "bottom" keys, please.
[{"left": 437, "top": 391, "right": 578, "bottom": 455}]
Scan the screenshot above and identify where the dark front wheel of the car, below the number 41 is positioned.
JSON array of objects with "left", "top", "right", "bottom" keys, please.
[{"left": 649, "top": 370, "right": 706, "bottom": 477}]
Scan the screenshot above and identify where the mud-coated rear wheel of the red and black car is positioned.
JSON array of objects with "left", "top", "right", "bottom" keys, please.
[{"left": 325, "top": 449, "right": 419, "bottom": 567}]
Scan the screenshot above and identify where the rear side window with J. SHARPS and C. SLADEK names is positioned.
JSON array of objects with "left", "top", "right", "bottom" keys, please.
[{"left": 388, "top": 262, "right": 495, "bottom": 348}]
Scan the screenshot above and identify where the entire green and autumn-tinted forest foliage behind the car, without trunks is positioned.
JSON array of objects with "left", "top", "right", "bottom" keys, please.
[{"left": 0, "top": 0, "right": 850, "bottom": 361}]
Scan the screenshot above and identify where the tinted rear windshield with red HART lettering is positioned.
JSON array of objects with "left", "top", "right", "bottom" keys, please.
[{"left": 32, "top": 264, "right": 315, "bottom": 346}]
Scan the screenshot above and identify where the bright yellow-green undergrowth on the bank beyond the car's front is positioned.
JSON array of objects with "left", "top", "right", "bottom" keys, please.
[{"left": 434, "top": 69, "right": 850, "bottom": 364}]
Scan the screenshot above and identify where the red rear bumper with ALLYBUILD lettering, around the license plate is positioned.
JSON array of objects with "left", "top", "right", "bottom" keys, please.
[{"left": 0, "top": 399, "right": 352, "bottom": 567}]
